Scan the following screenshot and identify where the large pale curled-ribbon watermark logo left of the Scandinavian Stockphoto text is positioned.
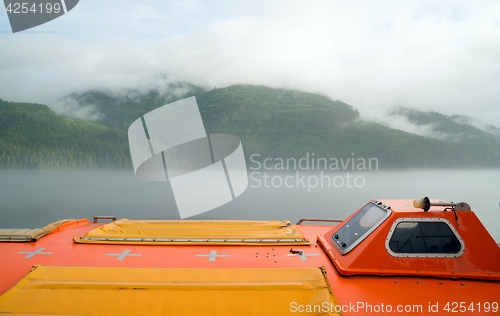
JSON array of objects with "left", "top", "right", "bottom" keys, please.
[{"left": 128, "top": 97, "right": 248, "bottom": 218}]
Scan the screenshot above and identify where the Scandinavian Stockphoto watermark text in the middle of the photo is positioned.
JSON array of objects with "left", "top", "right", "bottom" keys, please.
[{"left": 250, "top": 152, "right": 379, "bottom": 192}]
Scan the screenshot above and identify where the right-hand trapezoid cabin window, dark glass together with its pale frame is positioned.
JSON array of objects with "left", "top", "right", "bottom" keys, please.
[{"left": 386, "top": 218, "right": 463, "bottom": 257}]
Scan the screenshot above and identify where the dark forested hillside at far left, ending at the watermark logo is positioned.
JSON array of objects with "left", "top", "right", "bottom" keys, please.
[{"left": 0, "top": 99, "right": 131, "bottom": 170}]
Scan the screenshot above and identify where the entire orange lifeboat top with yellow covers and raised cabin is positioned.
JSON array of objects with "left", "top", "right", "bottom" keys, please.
[{"left": 0, "top": 198, "right": 500, "bottom": 316}]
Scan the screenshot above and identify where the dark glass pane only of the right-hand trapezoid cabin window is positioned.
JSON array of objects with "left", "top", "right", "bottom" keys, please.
[{"left": 389, "top": 222, "right": 461, "bottom": 254}]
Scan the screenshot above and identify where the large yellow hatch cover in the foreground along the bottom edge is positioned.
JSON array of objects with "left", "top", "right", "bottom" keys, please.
[{"left": 0, "top": 266, "right": 340, "bottom": 316}]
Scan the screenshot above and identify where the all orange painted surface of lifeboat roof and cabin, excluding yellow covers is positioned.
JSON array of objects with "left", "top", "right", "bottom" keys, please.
[{"left": 0, "top": 200, "right": 500, "bottom": 315}]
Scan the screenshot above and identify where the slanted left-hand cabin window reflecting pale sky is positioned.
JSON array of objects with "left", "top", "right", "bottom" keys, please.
[{"left": 332, "top": 201, "right": 391, "bottom": 254}]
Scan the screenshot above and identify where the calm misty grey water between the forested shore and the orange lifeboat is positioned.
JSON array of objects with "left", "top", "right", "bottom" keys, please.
[{"left": 0, "top": 170, "right": 500, "bottom": 242}]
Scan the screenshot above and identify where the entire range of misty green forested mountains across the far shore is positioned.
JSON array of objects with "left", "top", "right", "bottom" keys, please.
[{"left": 0, "top": 83, "right": 500, "bottom": 169}]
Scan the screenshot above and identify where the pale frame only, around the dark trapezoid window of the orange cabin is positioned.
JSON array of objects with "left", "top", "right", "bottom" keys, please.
[{"left": 385, "top": 217, "right": 465, "bottom": 258}]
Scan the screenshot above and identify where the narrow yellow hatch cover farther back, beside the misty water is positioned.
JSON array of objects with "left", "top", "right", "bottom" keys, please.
[{"left": 74, "top": 219, "right": 309, "bottom": 245}]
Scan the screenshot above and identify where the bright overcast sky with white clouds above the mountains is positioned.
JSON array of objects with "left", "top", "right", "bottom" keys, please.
[{"left": 0, "top": 0, "right": 500, "bottom": 126}]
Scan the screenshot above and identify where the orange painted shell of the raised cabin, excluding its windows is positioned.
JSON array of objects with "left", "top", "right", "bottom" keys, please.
[{"left": 318, "top": 200, "right": 500, "bottom": 280}]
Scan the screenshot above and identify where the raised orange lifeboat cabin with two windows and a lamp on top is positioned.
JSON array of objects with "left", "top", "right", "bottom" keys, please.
[{"left": 318, "top": 198, "right": 500, "bottom": 281}]
